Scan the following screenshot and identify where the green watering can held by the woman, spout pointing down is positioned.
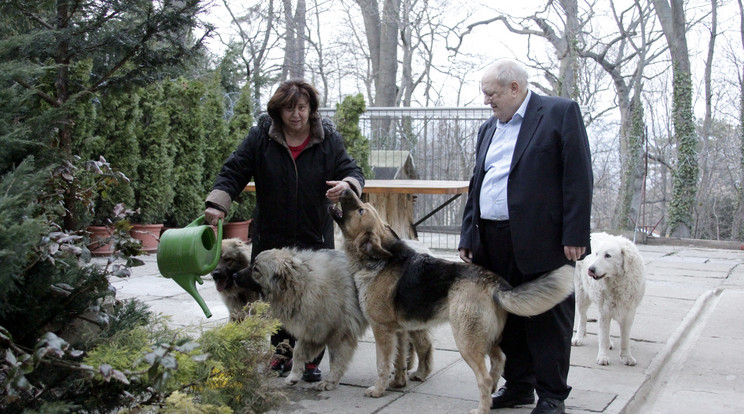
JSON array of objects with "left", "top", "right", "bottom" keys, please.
[{"left": 158, "top": 215, "right": 222, "bottom": 318}]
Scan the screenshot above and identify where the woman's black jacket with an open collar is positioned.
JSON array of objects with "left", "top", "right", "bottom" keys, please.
[{"left": 206, "top": 114, "right": 364, "bottom": 257}]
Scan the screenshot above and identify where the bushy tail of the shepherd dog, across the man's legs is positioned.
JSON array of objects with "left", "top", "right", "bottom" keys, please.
[{"left": 493, "top": 265, "right": 574, "bottom": 316}]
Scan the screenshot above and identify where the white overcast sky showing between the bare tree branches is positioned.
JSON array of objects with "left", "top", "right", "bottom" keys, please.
[{"left": 199, "top": 0, "right": 744, "bottom": 123}]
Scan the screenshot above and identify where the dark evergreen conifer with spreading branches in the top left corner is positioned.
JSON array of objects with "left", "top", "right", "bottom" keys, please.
[{"left": 0, "top": 0, "right": 210, "bottom": 229}]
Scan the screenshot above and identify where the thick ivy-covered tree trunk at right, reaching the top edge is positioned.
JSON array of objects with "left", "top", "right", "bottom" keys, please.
[{"left": 650, "top": 0, "right": 700, "bottom": 237}]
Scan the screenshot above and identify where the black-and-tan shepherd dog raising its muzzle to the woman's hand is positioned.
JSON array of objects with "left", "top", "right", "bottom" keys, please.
[{"left": 329, "top": 190, "right": 573, "bottom": 414}]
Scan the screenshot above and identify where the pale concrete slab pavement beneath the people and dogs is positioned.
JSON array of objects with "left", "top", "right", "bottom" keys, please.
[{"left": 107, "top": 244, "right": 744, "bottom": 414}]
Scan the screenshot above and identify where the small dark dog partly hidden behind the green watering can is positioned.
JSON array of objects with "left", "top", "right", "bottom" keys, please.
[{"left": 211, "top": 239, "right": 260, "bottom": 321}]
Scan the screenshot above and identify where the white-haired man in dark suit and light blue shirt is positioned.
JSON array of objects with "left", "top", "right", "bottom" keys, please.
[{"left": 459, "top": 59, "right": 593, "bottom": 414}]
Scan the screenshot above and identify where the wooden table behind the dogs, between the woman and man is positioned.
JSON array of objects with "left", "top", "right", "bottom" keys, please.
[{"left": 245, "top": 180, "right": 469, "bottom": 240}]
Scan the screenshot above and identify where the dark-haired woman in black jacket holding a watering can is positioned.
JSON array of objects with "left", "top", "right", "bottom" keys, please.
[{"left": 204, "top": 80, "right": 364, "bottom": 382}]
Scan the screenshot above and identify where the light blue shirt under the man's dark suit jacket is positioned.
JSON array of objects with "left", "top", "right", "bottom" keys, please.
[{"left": 480, "top": 90, "right": 532, "bottom": 220}]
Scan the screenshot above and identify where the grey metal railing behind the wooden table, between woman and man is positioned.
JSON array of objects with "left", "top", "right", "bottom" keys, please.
[{"left": 320, "top": 107, "right": 492, "bottom": 250}]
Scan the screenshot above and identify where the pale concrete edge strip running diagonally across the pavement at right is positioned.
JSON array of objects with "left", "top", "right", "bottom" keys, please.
[{"left": 618, "top": 288, "right": 723, "bottom": 414}]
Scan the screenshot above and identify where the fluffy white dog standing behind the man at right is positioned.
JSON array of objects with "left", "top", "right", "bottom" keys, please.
[{"left": 571, "top": 233, "right": 646, "bottom": 365}]
